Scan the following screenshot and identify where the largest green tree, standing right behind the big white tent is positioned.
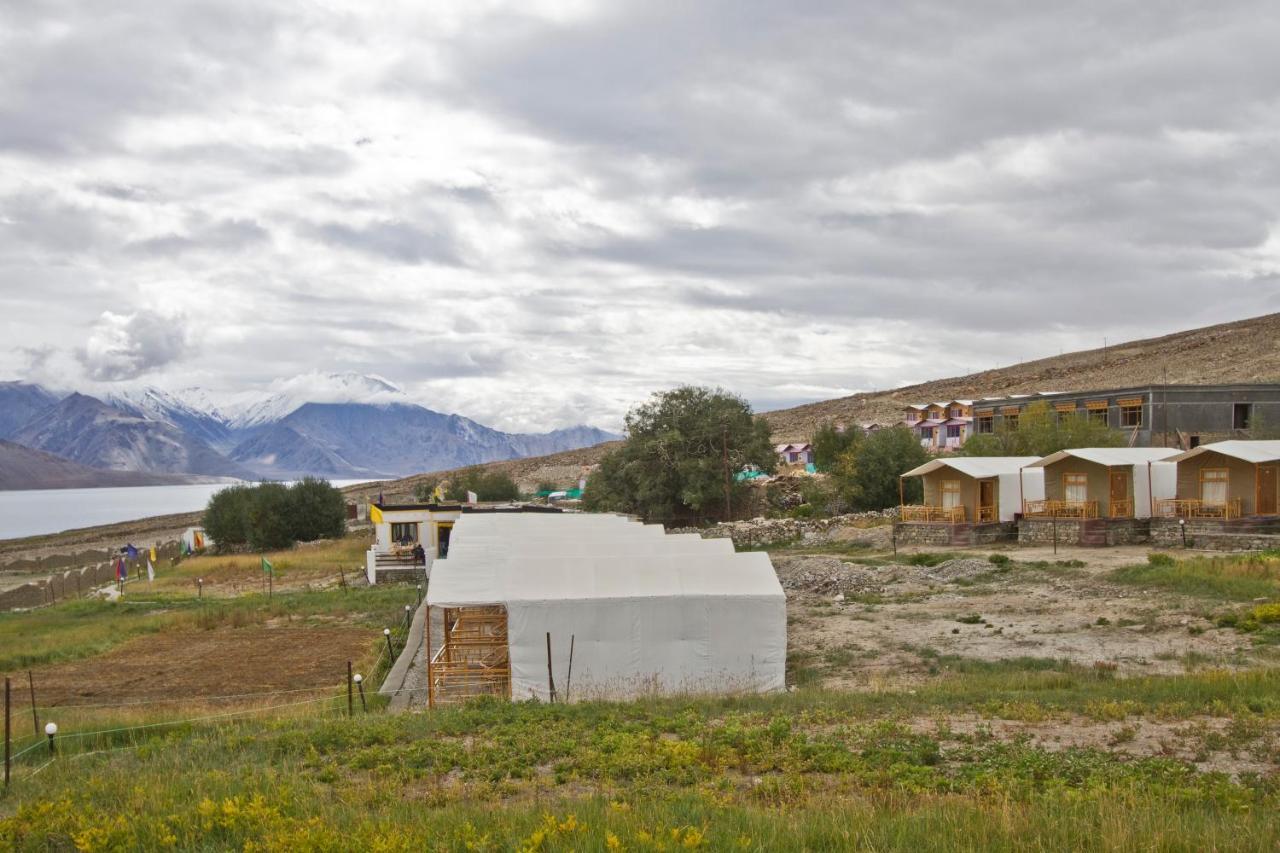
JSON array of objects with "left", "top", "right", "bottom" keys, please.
[{"left": 582, "top": 386, "right": 777, "bottom": 521}]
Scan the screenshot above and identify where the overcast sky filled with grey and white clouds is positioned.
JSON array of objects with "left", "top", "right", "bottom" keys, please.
[{"left": 0, "top": 0, "right": 1280, "bottom": 429}]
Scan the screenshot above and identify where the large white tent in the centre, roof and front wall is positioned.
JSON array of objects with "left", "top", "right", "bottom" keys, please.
[{"left": 426, "top": 514, "right": 786, "bottom": 701}]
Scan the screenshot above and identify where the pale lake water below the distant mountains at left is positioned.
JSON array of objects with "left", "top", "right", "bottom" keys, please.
[{"left": 0, "top": 480, "right": 365, "bottom": 539}]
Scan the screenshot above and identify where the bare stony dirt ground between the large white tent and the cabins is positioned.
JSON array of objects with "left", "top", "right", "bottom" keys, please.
[{"left": 773, "top": 548, "right": 1256, "bottom": 689}]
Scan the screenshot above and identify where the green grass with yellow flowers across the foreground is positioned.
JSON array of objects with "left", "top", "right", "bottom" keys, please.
[{"left": 0, "top": 674, "right": 1280, "bottom": 850}]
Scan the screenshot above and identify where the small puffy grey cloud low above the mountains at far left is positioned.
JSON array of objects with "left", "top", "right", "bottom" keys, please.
[{"left": 77, "top": 311, "right": 188, "bottom": 382}]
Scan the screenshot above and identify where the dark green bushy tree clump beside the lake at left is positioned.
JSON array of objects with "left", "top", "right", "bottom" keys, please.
[{"left": 204, "top": 478, "right": 347, "bottom": 551}]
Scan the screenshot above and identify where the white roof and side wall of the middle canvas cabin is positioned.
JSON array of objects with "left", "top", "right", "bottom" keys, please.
[{"left": 1029, "top": 447, "right": 1178, "bottom": 519}]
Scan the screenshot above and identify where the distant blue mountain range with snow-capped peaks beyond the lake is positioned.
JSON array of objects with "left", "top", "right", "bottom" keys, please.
[{"left": 0, "top": 374, "right": 617, "bottom": 488}]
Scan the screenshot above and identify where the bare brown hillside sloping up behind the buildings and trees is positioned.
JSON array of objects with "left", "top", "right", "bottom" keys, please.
[{"left": 344, "top": 314, "right": 1280, "bottom": 501}]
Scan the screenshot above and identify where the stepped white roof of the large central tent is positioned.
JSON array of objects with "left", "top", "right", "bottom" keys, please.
[{"left": 428, "top": 514, "right": 785, "bottom": 607}]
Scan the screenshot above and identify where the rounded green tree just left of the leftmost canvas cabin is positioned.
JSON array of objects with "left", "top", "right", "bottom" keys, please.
[{"left": 831, "top": 427, "right": 929, "bottom": 510}]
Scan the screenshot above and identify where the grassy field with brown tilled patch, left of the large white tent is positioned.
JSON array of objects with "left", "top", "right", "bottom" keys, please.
[{"left": 0, "top": 538, "right": 417, "bottom": 725}]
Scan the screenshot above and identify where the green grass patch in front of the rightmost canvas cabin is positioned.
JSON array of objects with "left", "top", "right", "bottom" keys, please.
[{"left": 1110, "top": 555, "right": 1280, "bottom": 601}]
